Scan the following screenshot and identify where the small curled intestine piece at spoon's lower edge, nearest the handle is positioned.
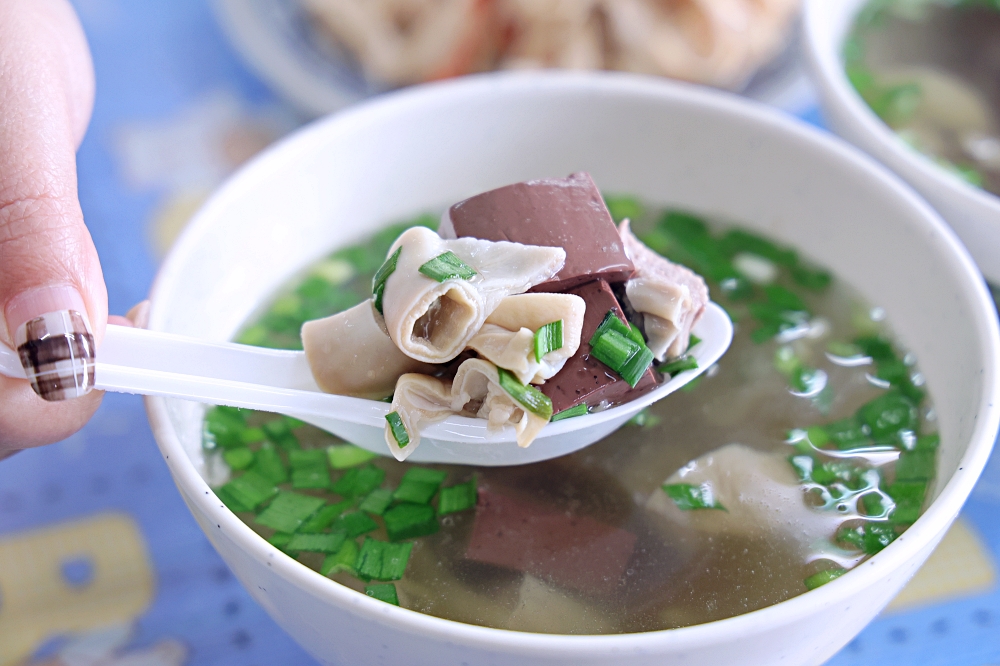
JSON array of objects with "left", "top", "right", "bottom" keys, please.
[{"left": 385, "top": 373, "right": 455, "bottom": 460}]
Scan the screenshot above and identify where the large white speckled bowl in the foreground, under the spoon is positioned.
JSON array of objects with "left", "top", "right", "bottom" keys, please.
[{"left": 147, "top": 73, "right": 1000, "bottom": 666}]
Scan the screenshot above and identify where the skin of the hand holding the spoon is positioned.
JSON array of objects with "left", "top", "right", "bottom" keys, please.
[{"left": 0, "top": 0, "right": 108, "bottom": 452}]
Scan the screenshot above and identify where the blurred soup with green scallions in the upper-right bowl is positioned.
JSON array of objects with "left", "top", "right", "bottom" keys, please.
[{"left": 844, "top": 0, "right": 1000, "bottom": 194}]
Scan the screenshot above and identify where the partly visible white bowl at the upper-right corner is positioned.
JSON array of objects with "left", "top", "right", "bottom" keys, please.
[{"left": 803, "top": 0, "right": 1000, "bottom": 284}]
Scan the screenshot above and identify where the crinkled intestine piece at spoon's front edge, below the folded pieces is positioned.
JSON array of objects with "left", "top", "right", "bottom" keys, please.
[{"left": 451, "top": 358, "right": 549, "bottom": 448}]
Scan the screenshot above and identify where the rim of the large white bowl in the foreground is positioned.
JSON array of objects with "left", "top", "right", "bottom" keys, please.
[{"left": 145, "top": 72, "right": 1000, "bottom": 658}]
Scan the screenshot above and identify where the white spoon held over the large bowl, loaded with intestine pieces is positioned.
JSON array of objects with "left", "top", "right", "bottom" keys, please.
[{"left": 0, "top": 303, "right": 733, "bottom": 466}]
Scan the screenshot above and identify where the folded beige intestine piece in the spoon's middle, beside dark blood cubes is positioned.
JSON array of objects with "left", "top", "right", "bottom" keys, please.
[{"left": 469, "top": 293, "right": 587, "bottom": 384}]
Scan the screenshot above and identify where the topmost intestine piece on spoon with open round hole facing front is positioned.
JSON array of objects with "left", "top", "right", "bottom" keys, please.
[{"left": 382, "top": 227, "right": 566, "bottom": 363}]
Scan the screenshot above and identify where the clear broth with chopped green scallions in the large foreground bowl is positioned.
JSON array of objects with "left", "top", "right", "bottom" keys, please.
[{"left": 205, "top": 197, "right": 938, "bottom": 634}]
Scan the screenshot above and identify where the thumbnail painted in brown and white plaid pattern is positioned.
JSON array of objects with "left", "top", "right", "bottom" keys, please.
[{"left": 14, "top": 310, "right": 95, "bottom": 402}]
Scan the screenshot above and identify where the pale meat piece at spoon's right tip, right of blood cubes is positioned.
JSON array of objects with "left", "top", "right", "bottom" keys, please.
[{"left": 618, "top": 220, "right": 708, "bottom": 361}]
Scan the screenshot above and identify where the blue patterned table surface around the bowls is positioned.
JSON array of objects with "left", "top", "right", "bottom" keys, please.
[{"left": 0, "top": 0, "right": 1000, "bottom": 666}]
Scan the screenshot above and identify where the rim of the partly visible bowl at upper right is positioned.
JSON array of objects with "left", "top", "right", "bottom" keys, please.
[{"left": 801, "top": 0, "right": 1000, "bottom": 215}]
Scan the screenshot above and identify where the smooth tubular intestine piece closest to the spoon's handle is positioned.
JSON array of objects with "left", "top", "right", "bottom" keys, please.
[{"left": 302, "top": 299, "right": 432, "bottom": 399}]
